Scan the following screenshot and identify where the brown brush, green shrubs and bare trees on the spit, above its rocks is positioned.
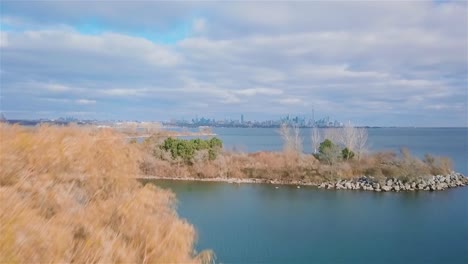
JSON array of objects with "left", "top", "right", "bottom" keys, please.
[{"left": 140, "top": 125, "right": 460, "bottom": 185}]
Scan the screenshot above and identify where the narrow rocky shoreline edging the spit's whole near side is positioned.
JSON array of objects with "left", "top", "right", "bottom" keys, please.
[{"left": 139, "top": 172, "right": 468, "bottom": 192}]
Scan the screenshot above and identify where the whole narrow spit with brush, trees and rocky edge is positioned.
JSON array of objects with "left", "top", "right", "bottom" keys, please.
[{"left": 139, "top": 124, "right": 468, "bottom": 192}]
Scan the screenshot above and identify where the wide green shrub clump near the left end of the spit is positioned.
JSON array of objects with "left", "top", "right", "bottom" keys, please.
[{"left": 160, "top": 137, "right": 223, "bottom": 162}]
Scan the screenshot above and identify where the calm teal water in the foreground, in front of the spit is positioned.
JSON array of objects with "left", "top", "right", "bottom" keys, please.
[{"left": 151, "top": 181, "right": 468, "bottom": 263}]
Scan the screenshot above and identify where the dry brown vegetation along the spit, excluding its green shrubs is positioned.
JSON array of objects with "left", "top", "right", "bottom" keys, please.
[{"left": 141, "top": 129, "right": 452, "bottom": 184}]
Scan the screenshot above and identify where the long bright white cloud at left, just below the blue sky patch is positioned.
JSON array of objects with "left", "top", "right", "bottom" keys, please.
[{"left": 4, "top": 29, "right": 181, "bottom": 67}]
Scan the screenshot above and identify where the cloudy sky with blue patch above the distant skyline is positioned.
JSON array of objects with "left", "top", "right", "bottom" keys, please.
[{"left": 0, "top": 0, "right": 468, "bottom": 127}]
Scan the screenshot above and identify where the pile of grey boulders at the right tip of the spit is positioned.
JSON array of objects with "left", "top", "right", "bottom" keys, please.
[{"left": 318, "top": 172, "right": 468, "bottom": 192}]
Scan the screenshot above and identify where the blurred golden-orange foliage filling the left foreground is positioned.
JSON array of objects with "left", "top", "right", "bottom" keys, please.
[{"left": 0, "top": 125, "right": 212, "bottom": 263}]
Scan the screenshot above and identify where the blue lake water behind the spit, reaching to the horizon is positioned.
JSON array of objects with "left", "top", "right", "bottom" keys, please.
[{"left": 213, "top": 128, "right": 468, "bottom": 175}]
